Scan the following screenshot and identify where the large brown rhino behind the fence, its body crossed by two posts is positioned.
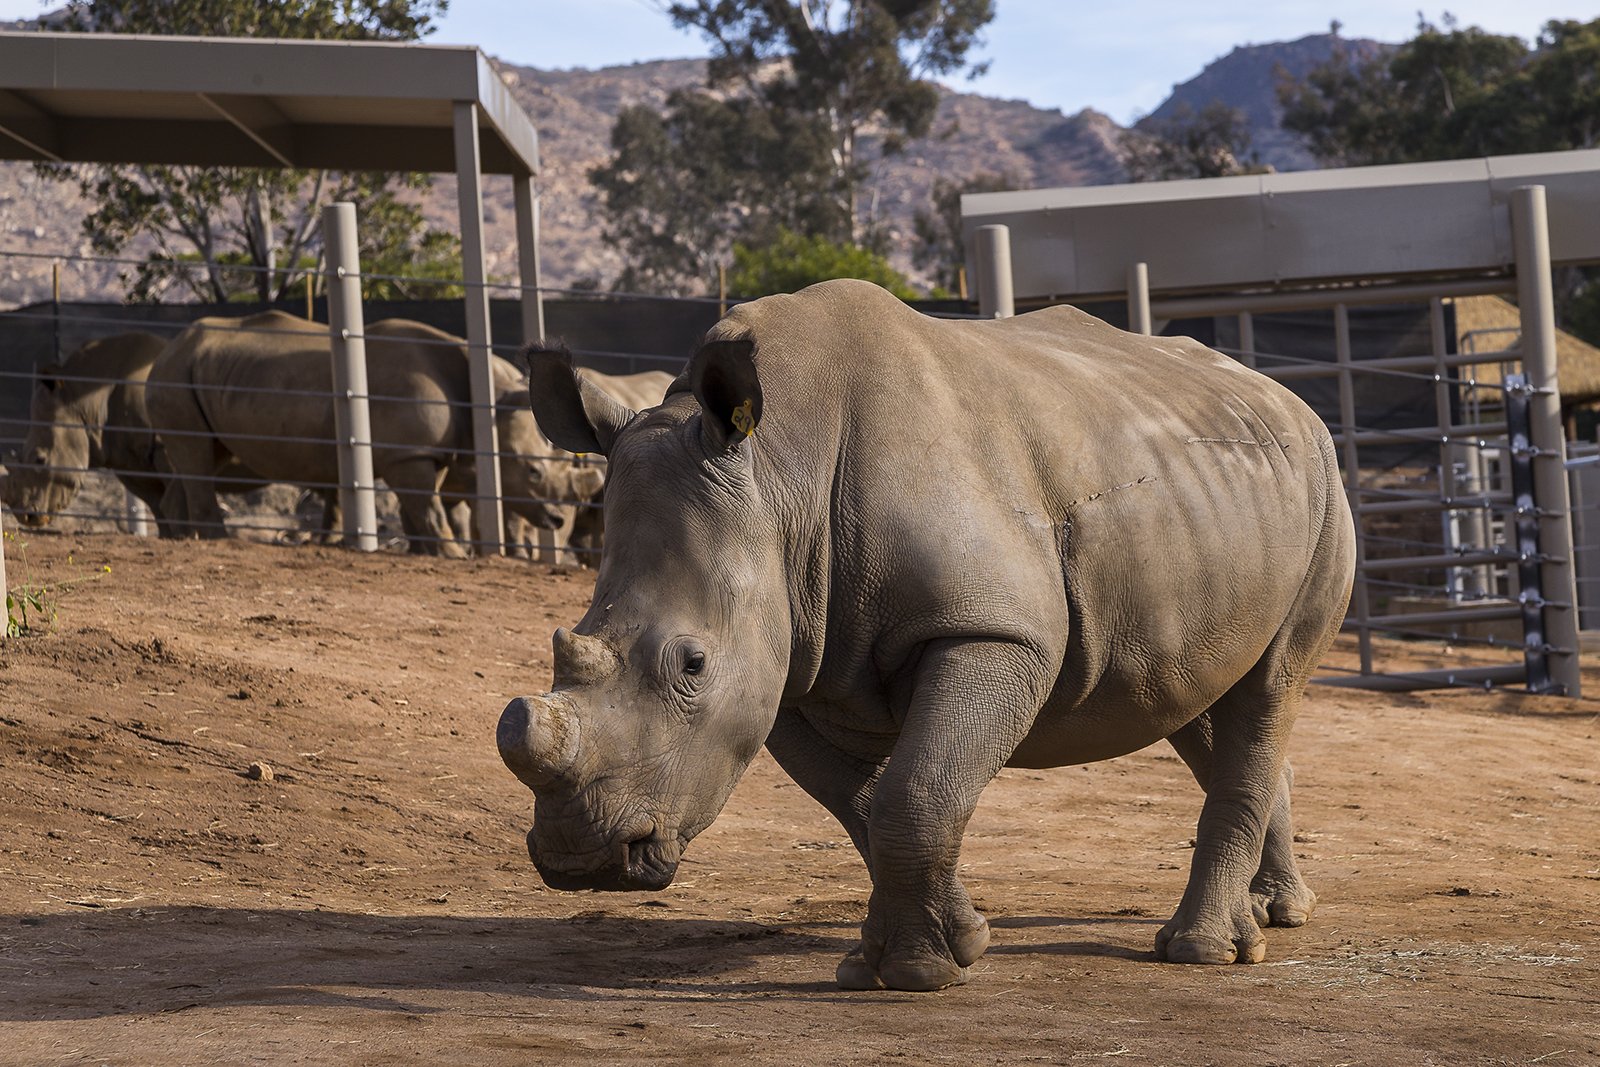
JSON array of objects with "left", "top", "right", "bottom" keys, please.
[{"left": 147, "top": 312, "right": 566, "bottom": 557}]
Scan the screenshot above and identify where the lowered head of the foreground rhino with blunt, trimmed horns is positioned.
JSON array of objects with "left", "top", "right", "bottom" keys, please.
[{"left": 496, "top": 341, "right": 790, "bottom": 889}]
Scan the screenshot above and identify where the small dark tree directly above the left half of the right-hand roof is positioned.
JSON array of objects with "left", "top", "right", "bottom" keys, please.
[{"left": 1118, "top": 101, "right": 1269, "bottom": 181}]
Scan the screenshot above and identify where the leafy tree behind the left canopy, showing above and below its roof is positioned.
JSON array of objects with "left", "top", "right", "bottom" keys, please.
[{"left": 40, "top": 0, "right": 458, "bottom": 302}]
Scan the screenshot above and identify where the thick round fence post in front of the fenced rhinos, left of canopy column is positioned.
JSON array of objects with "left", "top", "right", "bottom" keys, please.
[{"left": 322, "top": 203, "right": 378, "bottom": 552}]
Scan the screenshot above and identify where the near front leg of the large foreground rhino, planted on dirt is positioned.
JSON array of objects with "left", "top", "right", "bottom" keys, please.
[{"left": 838, "top": 640, "right": 1053, "bottom": 990}]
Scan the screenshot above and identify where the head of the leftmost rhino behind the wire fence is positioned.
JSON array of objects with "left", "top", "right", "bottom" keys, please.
[{"left": 3, "top": 365, "right": 91, "bottom": 526}]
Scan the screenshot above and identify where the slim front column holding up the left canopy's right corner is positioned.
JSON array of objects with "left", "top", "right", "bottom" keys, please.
[{"left": 456, "top": 101, "right": 506, "bottom": 555}]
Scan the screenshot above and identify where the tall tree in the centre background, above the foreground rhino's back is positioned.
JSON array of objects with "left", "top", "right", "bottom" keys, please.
[{"left": 590, "top": 0, "right": 994, "bottom": 290}]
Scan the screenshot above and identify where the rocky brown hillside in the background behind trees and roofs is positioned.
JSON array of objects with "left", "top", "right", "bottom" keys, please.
[{"left": 0, "top": 24, "right": 1331, "bottom": 307}]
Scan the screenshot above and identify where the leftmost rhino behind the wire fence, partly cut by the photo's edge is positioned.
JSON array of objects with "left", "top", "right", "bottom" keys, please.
[{"left": 5, "top": 333, "right": 166, "bottom": 526}]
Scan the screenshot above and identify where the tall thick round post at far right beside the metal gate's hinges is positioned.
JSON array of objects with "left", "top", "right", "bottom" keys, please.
[{"left": 1510, "top": 186, "right": 1582, "bottom": 697}]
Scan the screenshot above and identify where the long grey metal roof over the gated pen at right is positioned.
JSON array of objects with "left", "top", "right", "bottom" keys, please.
[{"left": 962, "top": 149, "right": 1600, "bottom": 301}]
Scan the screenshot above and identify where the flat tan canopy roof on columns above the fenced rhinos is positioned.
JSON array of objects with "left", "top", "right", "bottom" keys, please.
[{"left": 0, "top": 32, "right": 539, "bottom": 176}]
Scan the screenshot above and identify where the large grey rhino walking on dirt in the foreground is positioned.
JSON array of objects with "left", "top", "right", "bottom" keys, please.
[{"left": 498, "top": 282, "right": 1355, "bottom": 990}]
